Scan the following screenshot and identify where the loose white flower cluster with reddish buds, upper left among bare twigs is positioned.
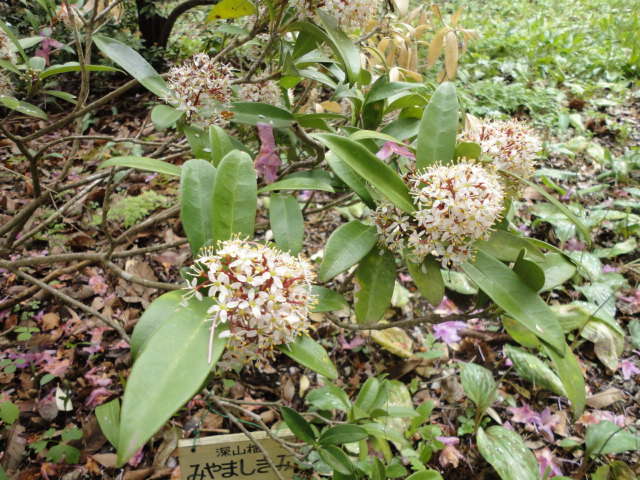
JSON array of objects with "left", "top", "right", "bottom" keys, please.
[{"left": 165, "top": 53, "right": 232, "bottom": 127}]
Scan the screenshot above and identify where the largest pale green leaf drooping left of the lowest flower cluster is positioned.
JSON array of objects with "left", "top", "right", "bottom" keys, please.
[{"left": 118, "top": 298, "right": 228, "bottom": 465}]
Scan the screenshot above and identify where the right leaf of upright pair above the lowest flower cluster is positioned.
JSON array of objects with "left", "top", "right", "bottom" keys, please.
[{"left": 212, "top": 150, "right": 258, "bottom": 241}]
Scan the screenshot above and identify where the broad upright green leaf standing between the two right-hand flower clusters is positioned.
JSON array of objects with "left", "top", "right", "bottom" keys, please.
[{"left": 416, "top": 82, "right": 458, "bottom": 170}]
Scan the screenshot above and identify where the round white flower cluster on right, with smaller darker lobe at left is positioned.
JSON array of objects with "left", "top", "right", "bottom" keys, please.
[{"left": 373, "top": 159, "right": 504, "bottom": 267}]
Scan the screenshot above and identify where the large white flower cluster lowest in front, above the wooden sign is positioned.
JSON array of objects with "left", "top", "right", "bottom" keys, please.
[{"left": 186, "top": 239, "right": 317, "bottom": 370}]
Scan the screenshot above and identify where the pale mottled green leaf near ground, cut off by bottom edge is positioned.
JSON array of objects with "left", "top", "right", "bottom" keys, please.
[{"left": 477, "top": 425, "right": 540, "bottom": 480}]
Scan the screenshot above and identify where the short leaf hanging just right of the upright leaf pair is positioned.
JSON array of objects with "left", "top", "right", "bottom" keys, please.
[{"left": 269, "top": 193, "right": 304, "bottom": 255}]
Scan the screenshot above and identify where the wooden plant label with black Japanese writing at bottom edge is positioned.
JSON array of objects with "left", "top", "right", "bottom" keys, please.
[{"left": 178, "top": 430, "right": 295, "bottom": 480}]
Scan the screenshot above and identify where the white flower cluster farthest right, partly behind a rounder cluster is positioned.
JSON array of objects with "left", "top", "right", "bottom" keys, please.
[{"left": 463, "top": 120, "right": 542, "bottom": 195}]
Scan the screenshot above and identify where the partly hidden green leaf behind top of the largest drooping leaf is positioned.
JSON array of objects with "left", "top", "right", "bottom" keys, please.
[{"left": 131, "top": 290, "right": 184, "bottom": 360}]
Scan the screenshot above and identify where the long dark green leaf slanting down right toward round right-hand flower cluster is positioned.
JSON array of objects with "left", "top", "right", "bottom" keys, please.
[{"left": 313, "top": 133, "right": 415, "bottom": 213}]
